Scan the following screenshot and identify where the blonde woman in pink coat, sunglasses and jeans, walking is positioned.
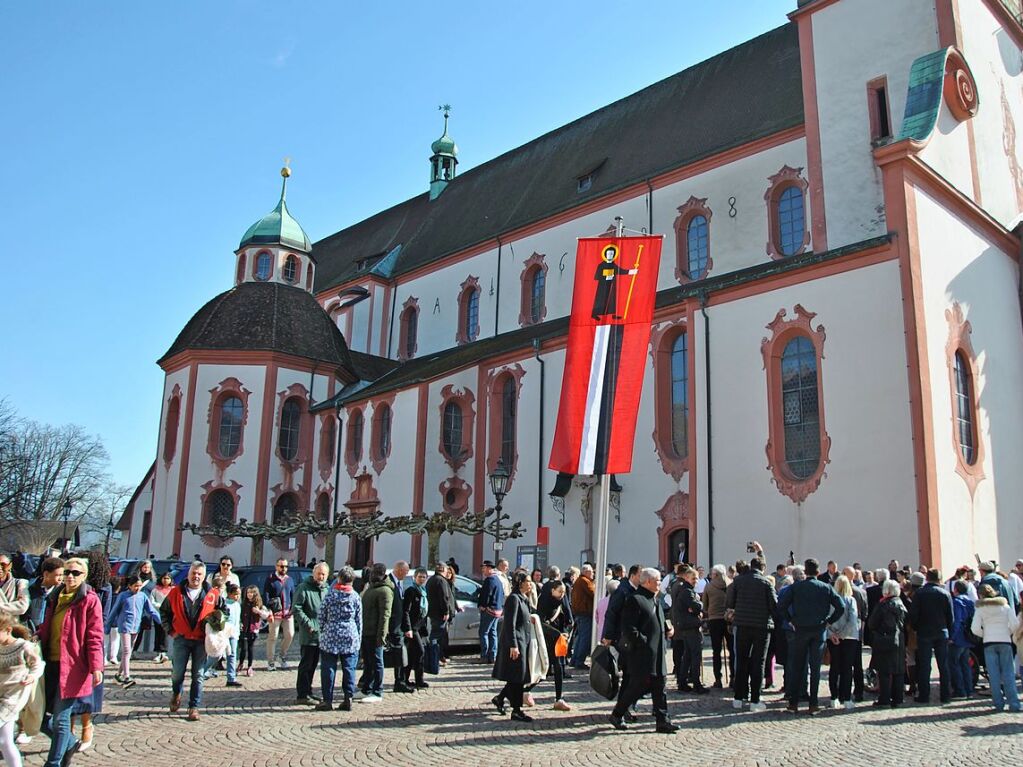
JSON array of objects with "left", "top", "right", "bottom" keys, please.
[{"left": 39, "top": 558, "right": 103, "bottom": 767}]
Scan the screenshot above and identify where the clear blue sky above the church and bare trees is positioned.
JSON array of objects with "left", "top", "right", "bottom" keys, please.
[{"left": 0, "top": 0, "right": 796, "bottom": 484}]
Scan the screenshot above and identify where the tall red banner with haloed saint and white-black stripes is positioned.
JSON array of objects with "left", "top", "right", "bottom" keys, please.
[{"left": 548, "top": 237, "right": 662, "bottom": 475}]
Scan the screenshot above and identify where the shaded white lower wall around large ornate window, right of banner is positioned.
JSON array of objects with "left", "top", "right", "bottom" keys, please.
[{"left": 694, "top": 261, "right": 918, "bottom": 565}]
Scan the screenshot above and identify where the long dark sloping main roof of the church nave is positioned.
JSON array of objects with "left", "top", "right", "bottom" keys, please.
[{"left": 313, "top": 24, "right": 803, "bottom": 291}]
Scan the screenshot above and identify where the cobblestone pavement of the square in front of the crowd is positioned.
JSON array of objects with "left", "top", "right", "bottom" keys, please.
[{"left": 25, "top": 647, "right": 1023, "bottom": 767}]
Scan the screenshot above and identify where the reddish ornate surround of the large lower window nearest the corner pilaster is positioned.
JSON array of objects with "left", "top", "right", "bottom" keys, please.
[{"left": 760, "top": 304, "right": 831, "bottom": 503}]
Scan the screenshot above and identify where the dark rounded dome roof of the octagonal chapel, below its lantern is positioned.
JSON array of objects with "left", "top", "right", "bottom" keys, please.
[{"left": 159, "top": 282, "right": 354, "bottom": 375}]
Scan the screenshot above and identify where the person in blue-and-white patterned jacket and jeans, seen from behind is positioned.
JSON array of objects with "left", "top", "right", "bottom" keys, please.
[{"left": 316, "top": 566, "right": 362, "bottom": 711}]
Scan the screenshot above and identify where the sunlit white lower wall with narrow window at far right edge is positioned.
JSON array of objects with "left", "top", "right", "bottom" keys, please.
[{"left": 916, "top": 185, "right": 1023, "bottom": 571}]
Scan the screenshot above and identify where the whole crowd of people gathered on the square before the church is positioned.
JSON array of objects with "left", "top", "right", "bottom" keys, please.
[{"left": 0, "top": 541, "right": 1023, "bottom": 767}]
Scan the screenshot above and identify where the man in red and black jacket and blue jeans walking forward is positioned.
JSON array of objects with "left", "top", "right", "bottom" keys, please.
[{"left": 160, "top": 561, "right": 224, "bottom": 722}]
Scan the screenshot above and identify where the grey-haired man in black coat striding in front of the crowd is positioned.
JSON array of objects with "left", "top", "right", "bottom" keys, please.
[{"left": 605, "top": 568, "right": 678, "bottom": 733}]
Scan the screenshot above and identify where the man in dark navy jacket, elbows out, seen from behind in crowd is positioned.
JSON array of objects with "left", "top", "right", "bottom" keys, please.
[{"left": 777, "top": 558, "right": 845, "bottom": 716}]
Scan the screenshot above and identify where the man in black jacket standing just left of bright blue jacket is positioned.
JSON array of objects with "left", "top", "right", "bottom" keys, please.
[{"left": 909, "top": 569, "right": 954, "bottom": 704}]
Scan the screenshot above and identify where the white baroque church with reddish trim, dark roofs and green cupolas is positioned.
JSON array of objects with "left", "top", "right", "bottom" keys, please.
[{"left": 123, "top": 0, "right": 1023, "bottom": 572}]
